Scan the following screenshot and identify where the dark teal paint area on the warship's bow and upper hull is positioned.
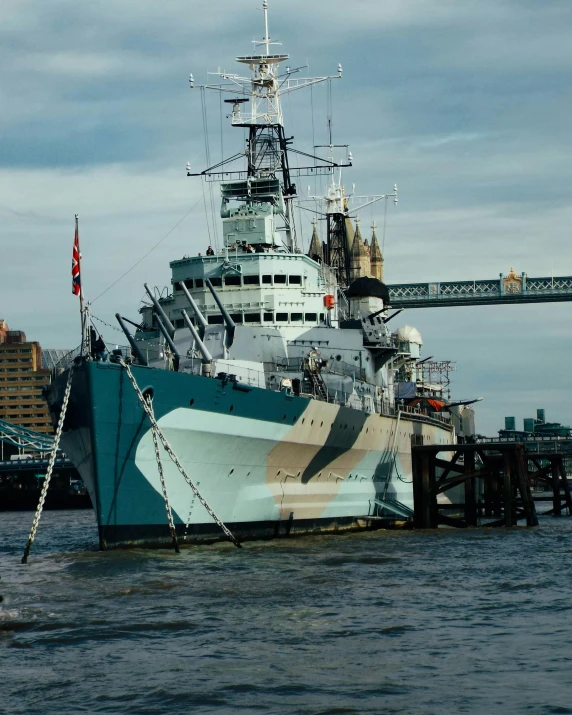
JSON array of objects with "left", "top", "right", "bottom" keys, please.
[{"left": 52, "top": 361, "right": 318, "bottom": 549}]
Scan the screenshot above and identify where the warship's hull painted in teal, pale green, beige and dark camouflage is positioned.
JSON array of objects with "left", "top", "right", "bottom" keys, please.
[{"left": 48, "top": 362, "right": 453, "bottom": 549}]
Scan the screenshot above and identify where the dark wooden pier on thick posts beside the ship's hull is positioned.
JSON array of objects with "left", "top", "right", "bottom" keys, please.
[{"left": 412, "top": 442, "right": 572, "bottom": 529}]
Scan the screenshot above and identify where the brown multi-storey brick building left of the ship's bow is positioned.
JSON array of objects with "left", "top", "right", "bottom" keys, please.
[{"left": 0, "top": 319, "right": 53, "bottom": 432}]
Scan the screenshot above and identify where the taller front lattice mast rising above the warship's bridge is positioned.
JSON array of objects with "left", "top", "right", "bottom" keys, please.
[{"left": 187, "top": 0, "right": 350, "bottom": 251}]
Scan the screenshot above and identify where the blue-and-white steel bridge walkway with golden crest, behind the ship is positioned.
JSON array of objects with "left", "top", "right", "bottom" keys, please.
[{"left": 387, "top": 268, "right": 572, "bottom": 308}]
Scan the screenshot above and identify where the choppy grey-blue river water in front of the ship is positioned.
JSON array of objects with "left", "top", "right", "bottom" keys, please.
[{"left": 0, "top": 512, "right": 572, "bottom": 715}]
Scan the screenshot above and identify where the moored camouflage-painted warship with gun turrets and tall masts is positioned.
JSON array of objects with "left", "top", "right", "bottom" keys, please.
[{"left": 46, "top": 0, "right": 457, "bottom": 549}]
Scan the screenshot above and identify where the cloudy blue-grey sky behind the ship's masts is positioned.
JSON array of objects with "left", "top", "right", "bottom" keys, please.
[{"left": 0, "top": 0, "right": 572, "bottom": 435}]
